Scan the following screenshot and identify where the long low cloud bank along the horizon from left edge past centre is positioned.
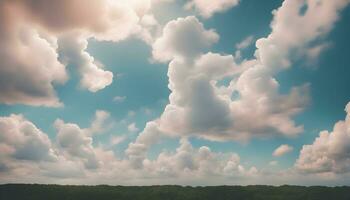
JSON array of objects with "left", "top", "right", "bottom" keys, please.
[{"left": 0, "top": 111, "right": 259, "bottom": 183}]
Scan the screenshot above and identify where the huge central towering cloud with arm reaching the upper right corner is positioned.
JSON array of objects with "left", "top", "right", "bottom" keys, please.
[{"left": 127, "top": 0, "right": 349, "bottom": 167}]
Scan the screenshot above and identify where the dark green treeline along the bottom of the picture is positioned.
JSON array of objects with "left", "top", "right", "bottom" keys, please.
[{"left": 0, "top": 184, "right": 350, "bottom": 200}]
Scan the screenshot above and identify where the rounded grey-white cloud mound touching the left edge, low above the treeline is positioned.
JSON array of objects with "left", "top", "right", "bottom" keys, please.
[{"left": 0, "top": 114, "right": 59, "bottom": 180}]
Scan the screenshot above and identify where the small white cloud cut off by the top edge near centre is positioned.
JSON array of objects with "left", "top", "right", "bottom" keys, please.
[{"left": 185, "top": 0, "right": 240, "bottom": 18}]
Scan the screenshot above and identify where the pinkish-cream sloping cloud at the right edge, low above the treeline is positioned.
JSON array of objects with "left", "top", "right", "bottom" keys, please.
[{"left": 295, "top": 103, "right": 350, "bottom": 174}]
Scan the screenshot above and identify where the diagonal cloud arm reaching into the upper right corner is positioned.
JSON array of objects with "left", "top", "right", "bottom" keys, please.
[{"left": 256, "top": 0, "right": 349, "bottom": 70}]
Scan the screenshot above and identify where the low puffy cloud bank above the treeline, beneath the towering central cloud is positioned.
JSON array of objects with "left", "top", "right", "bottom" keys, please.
[{"left": 143, "top": 138, "right": 258, "bottom": 178}]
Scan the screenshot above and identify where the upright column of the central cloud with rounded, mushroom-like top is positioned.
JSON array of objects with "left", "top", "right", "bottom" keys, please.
[{"left": 149, "top": 17, "right": 245, "bottom": 142}]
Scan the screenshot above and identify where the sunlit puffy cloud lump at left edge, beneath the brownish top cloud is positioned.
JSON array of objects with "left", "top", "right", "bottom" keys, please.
[{"left": 0, "top": 22, "right": 68, "bottom": 107}]
